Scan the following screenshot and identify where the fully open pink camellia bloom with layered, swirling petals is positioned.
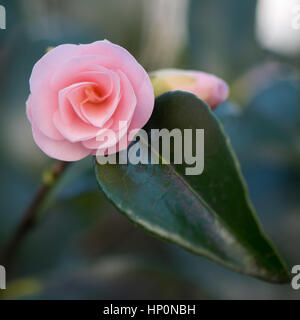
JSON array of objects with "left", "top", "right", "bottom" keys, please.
[{"left": 27, "top": 40, "right": 154, "bottom": 161}]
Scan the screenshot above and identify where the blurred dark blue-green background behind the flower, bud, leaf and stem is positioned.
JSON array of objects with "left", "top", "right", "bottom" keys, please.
[{"left": 0, "top": 0, "right": 300, "bottom": 299}]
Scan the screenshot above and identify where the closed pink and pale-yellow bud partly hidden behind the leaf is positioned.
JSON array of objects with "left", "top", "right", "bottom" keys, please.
[{"left": 151, "top": 69, "right": 229, "bottom": 109}]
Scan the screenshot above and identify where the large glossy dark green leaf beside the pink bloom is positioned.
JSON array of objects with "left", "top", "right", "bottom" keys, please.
[{"left": 95, "top": 91, "right": 289, "bottom": 282}]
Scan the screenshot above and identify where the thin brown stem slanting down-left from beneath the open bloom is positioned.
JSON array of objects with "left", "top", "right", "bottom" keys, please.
[{"left": 0, "top": 161, "right": 69, "bottom": 267}]
